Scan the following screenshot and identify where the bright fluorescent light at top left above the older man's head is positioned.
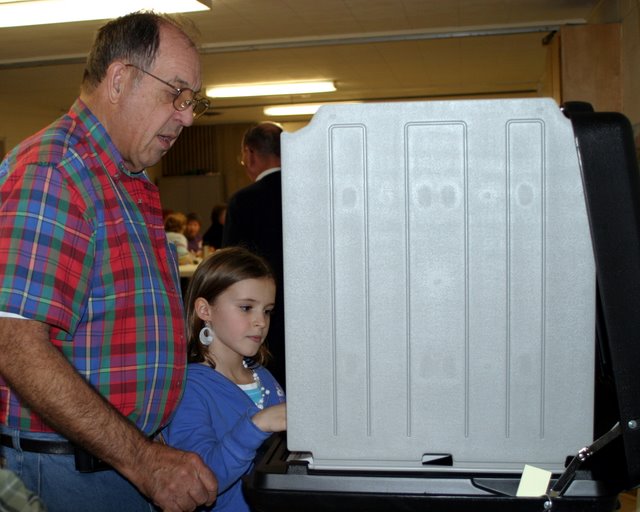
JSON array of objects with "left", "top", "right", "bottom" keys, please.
[{"left": 0, "top": 0, "right": 210, "bottom": 28}]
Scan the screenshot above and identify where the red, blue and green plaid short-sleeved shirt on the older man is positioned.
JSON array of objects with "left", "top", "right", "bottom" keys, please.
[{"left": 0, "top": 100, "right": 186, "bottom": 434}]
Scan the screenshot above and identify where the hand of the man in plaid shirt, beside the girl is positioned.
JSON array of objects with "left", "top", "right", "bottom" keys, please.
[{"left": 123, "top": 442, "right": 218, "bottom": 512}]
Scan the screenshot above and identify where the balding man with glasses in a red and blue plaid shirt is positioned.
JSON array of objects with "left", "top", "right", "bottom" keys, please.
[{"left": 0, "top": 9, "right": 217, "bottom": 512}]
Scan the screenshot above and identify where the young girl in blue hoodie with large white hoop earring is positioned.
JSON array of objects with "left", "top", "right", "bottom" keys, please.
[{"left": 163, "top": 247, "right": 286, "bottom": 512}]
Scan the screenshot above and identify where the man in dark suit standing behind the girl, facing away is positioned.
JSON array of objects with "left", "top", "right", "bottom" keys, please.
[{"left": 222, "top": 123, "right": 286, "bottom": 387}]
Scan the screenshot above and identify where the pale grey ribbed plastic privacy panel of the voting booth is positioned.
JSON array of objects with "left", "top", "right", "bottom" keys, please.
[{"left": 282, "top": 99, "right": 595, "bottom": 471}]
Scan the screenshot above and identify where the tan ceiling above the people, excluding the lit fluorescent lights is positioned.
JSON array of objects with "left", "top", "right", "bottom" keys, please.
[{"left": 0, "top": 0, "right": 599, "bottom": 123}]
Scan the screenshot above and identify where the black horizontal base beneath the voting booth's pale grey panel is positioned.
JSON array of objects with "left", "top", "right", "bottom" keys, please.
[{"left": 244, "top": 434, "right": 619, "bottom": 512}]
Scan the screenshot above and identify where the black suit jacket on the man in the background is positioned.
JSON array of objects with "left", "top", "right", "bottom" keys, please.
[{"left": 222, "top": 170, "right": 286, "bottom": 387}]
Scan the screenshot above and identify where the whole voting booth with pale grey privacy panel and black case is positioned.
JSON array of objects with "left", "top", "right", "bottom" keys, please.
[{"left": 244, "top": 99, "right": 640, "bottom": 512}]
